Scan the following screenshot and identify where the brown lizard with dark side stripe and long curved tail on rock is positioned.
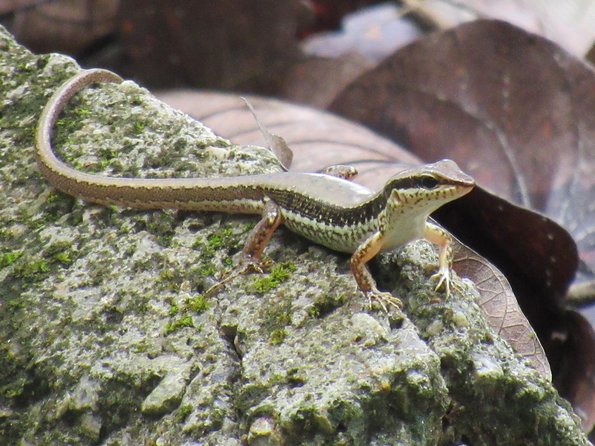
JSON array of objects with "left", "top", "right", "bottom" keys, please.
[{"left": 35, "top": 69, "right": 475, "bottom": 310}]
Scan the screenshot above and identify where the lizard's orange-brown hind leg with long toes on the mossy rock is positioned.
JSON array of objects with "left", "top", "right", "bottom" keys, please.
[{"left": 205, "top": 198, "right": 283, "bottom": 296}]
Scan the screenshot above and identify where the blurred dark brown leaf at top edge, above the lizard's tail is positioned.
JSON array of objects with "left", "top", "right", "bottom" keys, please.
[{"left": 119, "top": 0, "right": 307, "bottom": 88}]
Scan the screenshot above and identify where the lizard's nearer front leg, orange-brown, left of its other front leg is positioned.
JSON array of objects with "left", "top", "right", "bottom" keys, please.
[{"left": 350, "top": 231, "right": 403, "bottom": 311}]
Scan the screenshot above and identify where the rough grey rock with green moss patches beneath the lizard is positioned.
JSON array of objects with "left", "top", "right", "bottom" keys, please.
[{"left": 0, "top": 29, "right": 587, "bottom": 445}]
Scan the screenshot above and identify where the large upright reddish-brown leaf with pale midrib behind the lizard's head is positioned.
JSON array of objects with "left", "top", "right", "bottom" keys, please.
[{"left": 331, "top": 21, "right": 595, "bottom": 291}]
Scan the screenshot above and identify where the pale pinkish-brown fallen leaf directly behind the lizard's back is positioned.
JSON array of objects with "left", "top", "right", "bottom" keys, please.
[{"left": 155, "top": 90, "right": 419, "bottom": 180}]
